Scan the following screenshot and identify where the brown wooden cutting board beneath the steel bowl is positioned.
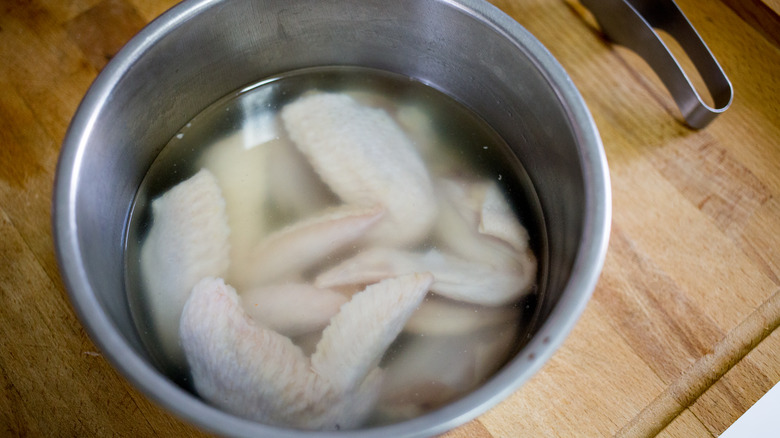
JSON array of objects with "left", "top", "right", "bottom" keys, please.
[{"left": 0, "top": 0, "right": 780, "bottom": 438}]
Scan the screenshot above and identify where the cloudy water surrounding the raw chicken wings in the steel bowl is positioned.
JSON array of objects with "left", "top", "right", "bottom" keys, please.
[{"left": 125, "top": 67, "right": 545, "bottom": 430}]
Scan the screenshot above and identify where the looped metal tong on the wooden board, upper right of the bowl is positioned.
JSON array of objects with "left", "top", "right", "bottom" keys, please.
[{"left": 580, "top": 0, "right": 734, "bottom": 129}]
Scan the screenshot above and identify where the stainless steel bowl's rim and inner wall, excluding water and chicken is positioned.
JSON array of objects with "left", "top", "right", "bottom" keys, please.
[{"left": 53, "top": 0, "right": 611, "bottom": 438}]
